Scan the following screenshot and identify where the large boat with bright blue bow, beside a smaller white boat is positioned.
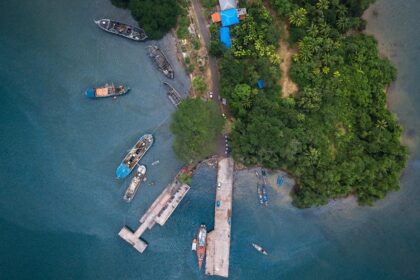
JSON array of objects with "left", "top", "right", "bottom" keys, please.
[{"left": 115, "top": 134, "right": 153, "bottom": 179}]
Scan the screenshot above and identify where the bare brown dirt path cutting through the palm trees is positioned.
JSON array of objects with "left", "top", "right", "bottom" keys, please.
[{"left": 263, "top": 0, "right": 298, "bottom": 97}]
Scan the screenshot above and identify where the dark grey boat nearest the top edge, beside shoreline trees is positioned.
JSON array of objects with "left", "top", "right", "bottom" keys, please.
[{"left": 95, "top": 18, "right": 147, "bottom": 41}]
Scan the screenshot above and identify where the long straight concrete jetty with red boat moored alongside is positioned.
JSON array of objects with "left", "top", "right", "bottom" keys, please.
[{"left": 206, "top": 158, "right": 233, "bottom": 277}]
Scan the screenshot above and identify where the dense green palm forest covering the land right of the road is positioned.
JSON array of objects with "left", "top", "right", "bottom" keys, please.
[{"left": 210, "top": 0, "right": 407, "bottom": 208}]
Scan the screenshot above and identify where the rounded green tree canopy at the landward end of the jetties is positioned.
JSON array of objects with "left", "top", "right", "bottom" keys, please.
[{"left": 171, "top": 99, "right": 224, "bottom": 164}]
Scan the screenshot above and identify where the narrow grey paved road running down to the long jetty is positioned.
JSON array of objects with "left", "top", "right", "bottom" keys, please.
[{"left": 191, "top": 0, "right": 229, "bottom": 156}]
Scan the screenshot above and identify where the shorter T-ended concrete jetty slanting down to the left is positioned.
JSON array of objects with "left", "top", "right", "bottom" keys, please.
[{"left": 118, "top": 179, "right": 190, "bottom": 253}]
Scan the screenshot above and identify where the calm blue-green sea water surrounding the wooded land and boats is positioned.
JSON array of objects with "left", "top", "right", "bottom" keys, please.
[{"left": 0, "top": 0, "right": 420, "bottom": 280}]
